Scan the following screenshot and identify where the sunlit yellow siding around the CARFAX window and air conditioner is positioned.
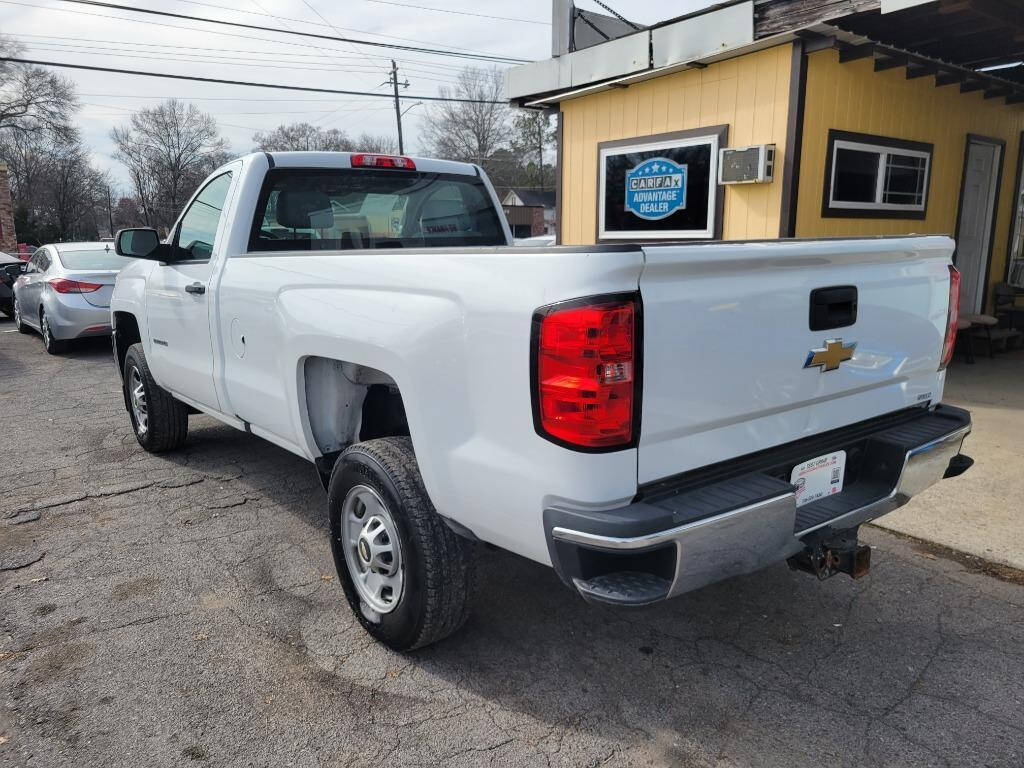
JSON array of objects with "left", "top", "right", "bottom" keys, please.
[{"left": 559, "top": 43, "right": 793, "bottom": 245}]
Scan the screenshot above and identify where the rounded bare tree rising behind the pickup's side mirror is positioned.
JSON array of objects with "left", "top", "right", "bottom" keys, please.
[{"left": 111, "top": 98, "right": 228, "bottom": 227}]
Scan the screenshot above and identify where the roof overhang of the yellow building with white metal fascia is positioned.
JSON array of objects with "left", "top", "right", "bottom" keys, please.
[{"left": 510, "top": 0, "right": 1024, "bottom": 109}]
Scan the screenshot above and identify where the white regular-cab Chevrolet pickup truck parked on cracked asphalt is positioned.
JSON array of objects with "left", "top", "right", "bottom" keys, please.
[{"left": 111, "top": 153, "right": 971, "bottom": 649}]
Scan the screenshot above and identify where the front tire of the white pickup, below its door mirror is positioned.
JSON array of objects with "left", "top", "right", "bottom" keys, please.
[{"left": 122, "top": 344, "right": 188, "bottom": 454}]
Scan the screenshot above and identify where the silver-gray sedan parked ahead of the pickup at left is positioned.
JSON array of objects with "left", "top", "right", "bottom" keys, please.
[{"left": 14, "top": 243, "right": 131, "bottom": 354}]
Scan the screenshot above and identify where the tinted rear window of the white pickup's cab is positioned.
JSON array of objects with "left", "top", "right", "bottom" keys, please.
[{"left": 249, "top": 168, "right": 506, "bottom": 251}]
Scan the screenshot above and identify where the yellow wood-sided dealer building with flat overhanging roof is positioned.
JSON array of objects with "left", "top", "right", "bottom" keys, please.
[{"left": 509, "top": 0, "right": 1024, "bottom": 311}]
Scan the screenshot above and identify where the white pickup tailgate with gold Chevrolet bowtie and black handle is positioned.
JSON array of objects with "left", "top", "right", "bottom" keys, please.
[{"left": 638, "top": 237, "right": 953, "bottom": 483}]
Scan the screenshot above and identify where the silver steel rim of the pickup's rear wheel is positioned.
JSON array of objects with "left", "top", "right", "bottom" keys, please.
[{"left": 341, "top": 485, "right": 404, "bottom": 613}]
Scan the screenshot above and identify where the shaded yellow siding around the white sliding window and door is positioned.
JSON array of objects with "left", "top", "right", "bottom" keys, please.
[{"left": 796, "top": 50, "right": 1024, "bottom": 307}]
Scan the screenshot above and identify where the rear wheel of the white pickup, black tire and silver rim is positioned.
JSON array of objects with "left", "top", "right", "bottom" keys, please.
[{"left": 328, "top": 437, "right": 474, "bottom": 651}]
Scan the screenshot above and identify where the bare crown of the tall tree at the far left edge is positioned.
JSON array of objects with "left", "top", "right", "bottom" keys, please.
[{"left": 0, "top": 35, "right": 78, "bottom": 138}]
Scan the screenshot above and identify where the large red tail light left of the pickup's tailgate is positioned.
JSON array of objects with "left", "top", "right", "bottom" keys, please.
[{"left": 530, "top": 294, "right": 640, "bottom": 452}]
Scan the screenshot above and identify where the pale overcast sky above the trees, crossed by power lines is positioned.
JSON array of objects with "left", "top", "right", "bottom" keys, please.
[{"left": 0, "top": 0, "right": 713, "bottom": 189}]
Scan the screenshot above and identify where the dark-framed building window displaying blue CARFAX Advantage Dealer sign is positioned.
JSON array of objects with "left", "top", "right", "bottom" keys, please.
[{"left": 597, "top": 126, "right": 728, "bottom": 241}]
